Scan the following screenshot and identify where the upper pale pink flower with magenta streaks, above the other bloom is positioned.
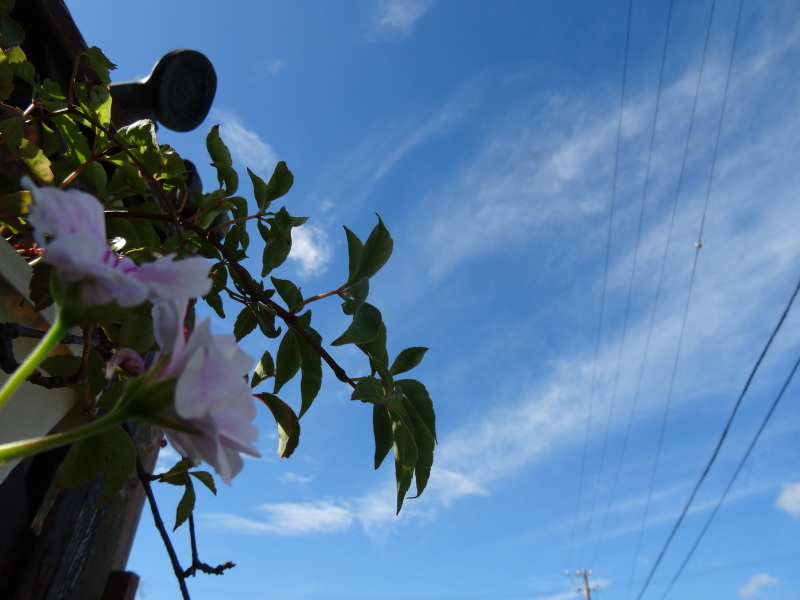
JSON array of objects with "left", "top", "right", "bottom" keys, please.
[{"left": 22, "top": 177, "right": 212, "bottom": 307}]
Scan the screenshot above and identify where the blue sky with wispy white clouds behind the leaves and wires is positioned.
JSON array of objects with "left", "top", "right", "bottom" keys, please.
[{"left": 67, "top": 0, "right": 800, "bottom": 600}]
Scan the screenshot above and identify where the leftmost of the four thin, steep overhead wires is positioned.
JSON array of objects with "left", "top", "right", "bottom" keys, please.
[{"left": 567, "top": 0, "right": 633, "bottom": 570}]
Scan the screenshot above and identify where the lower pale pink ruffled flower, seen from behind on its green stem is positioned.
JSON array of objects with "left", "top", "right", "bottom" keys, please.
[{"left": 153, "top": 301, "right": 261, "bottom": 484}]
